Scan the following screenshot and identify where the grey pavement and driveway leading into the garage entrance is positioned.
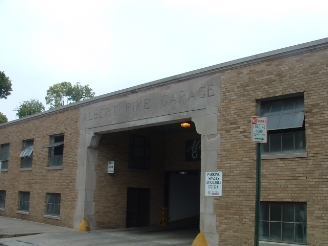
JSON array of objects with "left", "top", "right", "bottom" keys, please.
[{"left": 0, "top": 217, "right": 199, "bottom": 246}]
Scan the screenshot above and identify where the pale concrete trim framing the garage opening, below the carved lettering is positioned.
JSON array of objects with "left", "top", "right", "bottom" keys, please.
[{"left": 74, "top": 107, "right": 220, "bottom": 245}]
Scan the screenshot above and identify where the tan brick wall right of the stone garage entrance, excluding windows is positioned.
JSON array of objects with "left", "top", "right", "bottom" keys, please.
[{"left": 215, "top": 50, "right": 328, "bottom": 246}]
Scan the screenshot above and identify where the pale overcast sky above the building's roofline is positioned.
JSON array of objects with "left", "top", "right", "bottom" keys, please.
[{"left": 0, "top": 0, "right": 328, "bottom": 121}]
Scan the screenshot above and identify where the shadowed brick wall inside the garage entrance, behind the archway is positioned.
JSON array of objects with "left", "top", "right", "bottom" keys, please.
[{"left": 94, "top": 128, "right": 200, "bottom": 228}]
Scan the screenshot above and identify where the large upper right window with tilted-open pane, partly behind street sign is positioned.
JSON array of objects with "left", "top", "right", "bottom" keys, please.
[{"left": 260, "top": 96, "right": 306, "bottom": 154}]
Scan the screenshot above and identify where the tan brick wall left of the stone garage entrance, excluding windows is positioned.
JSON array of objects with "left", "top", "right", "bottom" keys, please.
[{"left": 0, "top": 109, "right": 79, "bottom": 227}]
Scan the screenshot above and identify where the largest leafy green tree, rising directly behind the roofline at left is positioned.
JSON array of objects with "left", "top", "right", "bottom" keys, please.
[{"left": 45, "top": 81, "right": 95, "bottom": 108}]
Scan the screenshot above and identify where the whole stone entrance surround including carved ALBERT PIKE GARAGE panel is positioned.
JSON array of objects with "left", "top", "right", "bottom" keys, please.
[{"left": 74, "top": 74, "right": 220, "bottom": 245}]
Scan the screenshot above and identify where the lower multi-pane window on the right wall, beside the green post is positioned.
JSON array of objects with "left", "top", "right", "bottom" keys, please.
[{"left": 260, "top": 202, "right": 306, "bottom": 243}]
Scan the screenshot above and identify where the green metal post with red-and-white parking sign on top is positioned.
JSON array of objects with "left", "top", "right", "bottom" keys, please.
[{"left": 251, "top": 116, "right": 267, "bottom": 246}]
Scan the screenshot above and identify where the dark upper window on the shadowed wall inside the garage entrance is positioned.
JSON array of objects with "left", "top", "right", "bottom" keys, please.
[{"left": 129, "top": 135, "right": 150, "bottom": 170}]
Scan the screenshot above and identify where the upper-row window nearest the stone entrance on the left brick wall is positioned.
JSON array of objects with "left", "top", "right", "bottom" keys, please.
[{"left": 44, "top": 134, "right": 64, "bottom": 167}]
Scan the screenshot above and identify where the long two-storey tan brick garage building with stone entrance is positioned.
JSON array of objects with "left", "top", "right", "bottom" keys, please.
[{"left": 0, "top": 39, "right": 328, "bottom": 246}]
